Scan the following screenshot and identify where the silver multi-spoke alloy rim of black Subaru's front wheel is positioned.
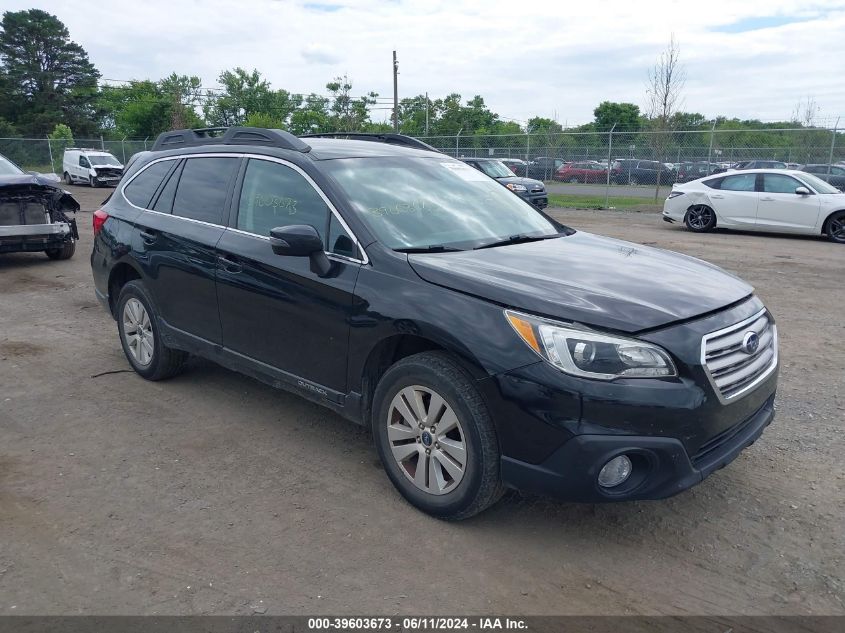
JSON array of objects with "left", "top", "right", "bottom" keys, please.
[{"left": 387, "top": 385, "right": 467, "bottom": 495}]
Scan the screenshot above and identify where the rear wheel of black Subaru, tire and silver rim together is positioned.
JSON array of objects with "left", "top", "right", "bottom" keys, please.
[{"left": 117, "top": 280, "right": 188, "bottom": 380}]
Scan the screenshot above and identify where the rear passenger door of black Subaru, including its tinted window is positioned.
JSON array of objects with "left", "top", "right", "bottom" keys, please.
[{"left": 127, "top": 155, "right": 241, "bottom": 344}]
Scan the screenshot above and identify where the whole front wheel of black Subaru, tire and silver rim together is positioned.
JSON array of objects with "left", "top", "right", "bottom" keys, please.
[{"left": 372, "top": 352, "right": 503, "bottom": 520}]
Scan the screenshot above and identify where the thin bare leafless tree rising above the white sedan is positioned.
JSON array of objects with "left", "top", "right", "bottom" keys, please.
[{"left": 646, "top": 35, "right": 686, "bottom": 202}]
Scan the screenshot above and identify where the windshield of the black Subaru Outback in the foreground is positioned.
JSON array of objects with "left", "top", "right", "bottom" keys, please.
[{"left": 325, "top": 156, "right": 561, "bottom": 249}]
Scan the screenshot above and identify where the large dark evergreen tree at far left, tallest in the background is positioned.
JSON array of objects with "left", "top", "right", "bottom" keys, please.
[{"left": 0, "top": 9, "right": 100, "bottom": 136}]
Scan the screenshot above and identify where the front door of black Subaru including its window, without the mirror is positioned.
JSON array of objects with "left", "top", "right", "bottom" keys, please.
[{"left": 217, "top": 158, "right": 363, "bottom": 394}]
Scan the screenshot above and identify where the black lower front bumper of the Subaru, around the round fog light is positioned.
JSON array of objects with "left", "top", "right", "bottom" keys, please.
[{"left": 501, "top": 395, "right": 775, "bottom": 503}]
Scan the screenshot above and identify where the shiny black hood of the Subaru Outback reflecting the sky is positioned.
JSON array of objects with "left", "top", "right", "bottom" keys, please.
[{"left": 408, "top": 232, "right": 753, "bottom": 332}]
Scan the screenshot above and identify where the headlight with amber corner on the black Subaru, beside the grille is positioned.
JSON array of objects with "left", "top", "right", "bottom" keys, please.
[{"left": 505, "top": 310, "right": 678, "bottom": 380}]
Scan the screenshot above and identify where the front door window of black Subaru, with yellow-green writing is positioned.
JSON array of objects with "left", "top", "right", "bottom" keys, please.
[{"left": 239, "top": 159, "right": 329, "bottom": 239}]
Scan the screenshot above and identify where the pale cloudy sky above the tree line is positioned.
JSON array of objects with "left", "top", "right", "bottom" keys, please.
[{"left": 3, "top": 0, "right": 845, "bottom": 126}]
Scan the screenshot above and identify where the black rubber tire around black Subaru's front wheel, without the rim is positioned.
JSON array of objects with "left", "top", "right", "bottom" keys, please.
[{"left": 371, "top": 352, "right": 504, "bottom": 521}]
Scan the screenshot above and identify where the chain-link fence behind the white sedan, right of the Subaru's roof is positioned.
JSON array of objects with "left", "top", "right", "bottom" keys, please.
[{"left": 412, "top": 128, "right": 845, "bottom": 186}]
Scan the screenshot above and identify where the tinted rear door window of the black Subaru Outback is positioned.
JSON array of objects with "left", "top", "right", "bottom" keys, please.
[{"left": 173, "top": 157, "right": 240, "bottom": 224}]
